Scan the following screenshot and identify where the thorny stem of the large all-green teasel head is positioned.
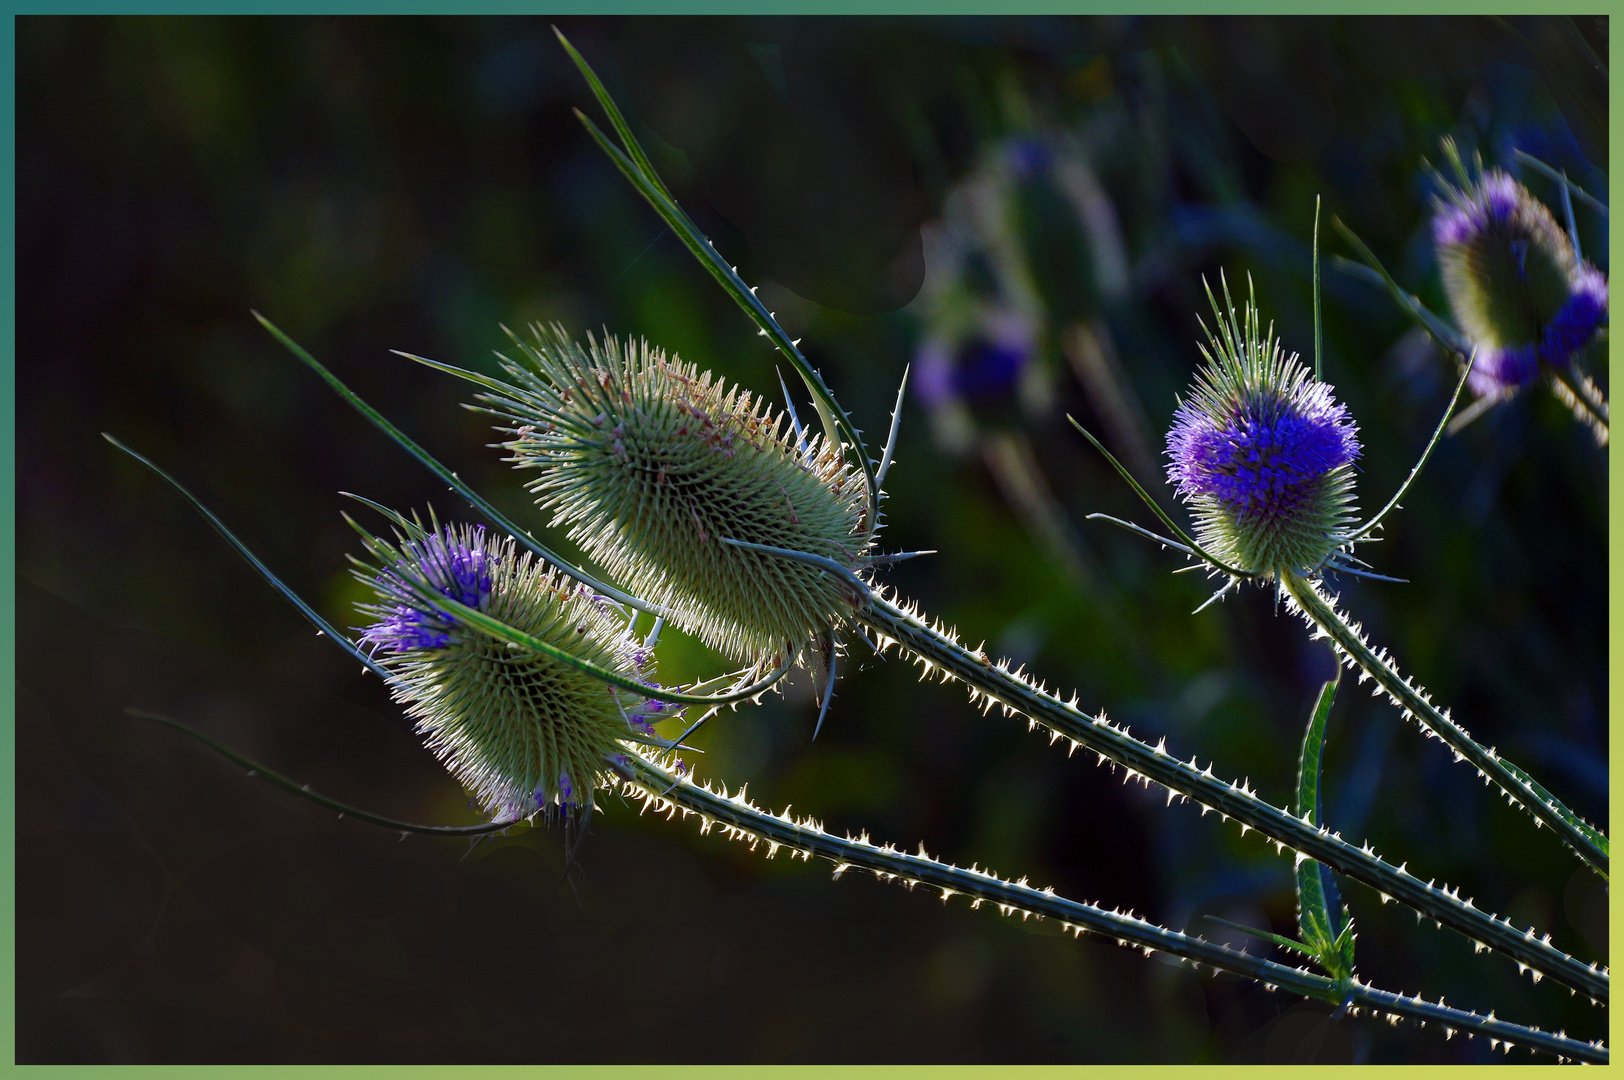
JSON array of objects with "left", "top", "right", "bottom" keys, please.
[{"left": 856, "top": 593, "right": 1608, "bottom": 1002}]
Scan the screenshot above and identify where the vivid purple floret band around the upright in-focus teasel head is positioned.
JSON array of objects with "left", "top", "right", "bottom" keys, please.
[{"left": 1168, "top": 385, "right": 1359, "bottom": 518}]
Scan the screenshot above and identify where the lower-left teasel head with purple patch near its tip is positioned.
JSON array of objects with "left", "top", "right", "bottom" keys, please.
[{"left": 357, "top": 526, "right": 663, "bottom": 820}]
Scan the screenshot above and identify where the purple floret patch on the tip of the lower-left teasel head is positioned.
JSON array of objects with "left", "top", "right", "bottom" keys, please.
[{"left": 361, "top": 526, "right": 490, "bottom": 653}]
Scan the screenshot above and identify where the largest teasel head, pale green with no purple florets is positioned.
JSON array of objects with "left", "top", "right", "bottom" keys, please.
[{"left": 484, "top": 326, "right": 872, "bottom": 663}]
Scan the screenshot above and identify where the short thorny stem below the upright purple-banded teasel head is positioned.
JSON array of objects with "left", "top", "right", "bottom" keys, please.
[{"left": 1280, "top": 573, "right": 1608, "bottom": 875}]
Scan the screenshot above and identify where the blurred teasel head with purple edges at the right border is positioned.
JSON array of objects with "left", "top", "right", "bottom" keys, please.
[{"left": 1432, "top": 169, "right": 1608, "bottom": 396}]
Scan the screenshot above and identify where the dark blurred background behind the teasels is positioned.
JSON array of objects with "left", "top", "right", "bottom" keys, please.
[{"left": 16, "top": 16, "right": 1608, "bottom": 1062}]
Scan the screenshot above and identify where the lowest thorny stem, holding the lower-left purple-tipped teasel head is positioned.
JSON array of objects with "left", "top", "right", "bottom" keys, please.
[{"left": 615, "top": 755, "right": 1608, "bottom": 1062}]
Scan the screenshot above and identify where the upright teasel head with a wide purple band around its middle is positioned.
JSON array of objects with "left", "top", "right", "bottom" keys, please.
[{"left": 1168, "top": 286, "right": 1359, "bottom": 577}]
